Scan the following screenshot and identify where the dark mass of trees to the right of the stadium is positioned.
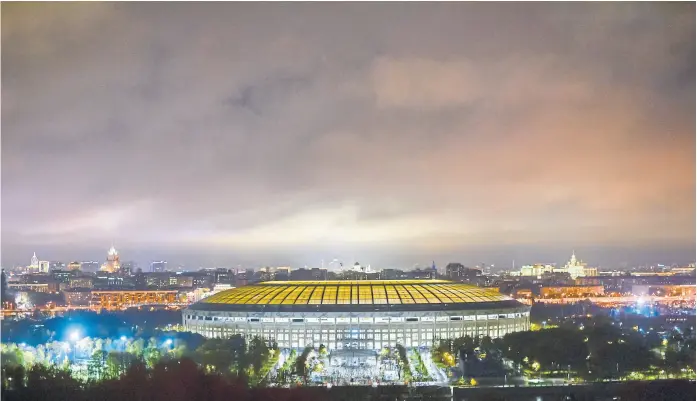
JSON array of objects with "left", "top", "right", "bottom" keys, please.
[{"left": 434, "top": 318, "right": 695, "bottom": 380}]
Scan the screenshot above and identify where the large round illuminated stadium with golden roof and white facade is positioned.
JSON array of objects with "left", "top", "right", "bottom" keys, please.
[{"left": 183, "top": 280, "right": 530, "bottom": 350}]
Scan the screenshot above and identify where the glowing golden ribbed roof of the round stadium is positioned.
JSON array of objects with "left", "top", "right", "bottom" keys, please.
[{"left": 189, "top": 280, "right": 515, "bottom": 310}]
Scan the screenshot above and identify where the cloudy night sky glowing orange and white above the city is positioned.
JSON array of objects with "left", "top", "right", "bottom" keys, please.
[{"left": 1, "top": 3, "right": 695, "bottom": 268}]
